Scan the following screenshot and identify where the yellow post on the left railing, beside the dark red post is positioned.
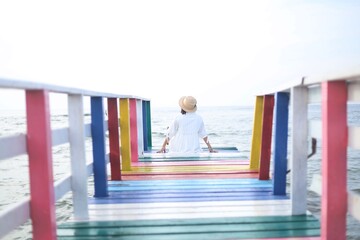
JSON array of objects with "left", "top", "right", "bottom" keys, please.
[{"left": 119, "top": 98, "right": 131, "bottom": 171}]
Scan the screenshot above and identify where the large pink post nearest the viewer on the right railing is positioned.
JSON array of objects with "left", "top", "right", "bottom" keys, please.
[{"left": 321, "top": 81, "right": 348, "bottom": 240}]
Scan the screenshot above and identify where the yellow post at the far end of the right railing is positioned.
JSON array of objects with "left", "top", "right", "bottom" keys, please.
[{"left": 250, "top": 96, "right": 264, "bottom": 170}]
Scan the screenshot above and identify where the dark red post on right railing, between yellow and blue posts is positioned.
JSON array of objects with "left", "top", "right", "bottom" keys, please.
[{"left": 259, "top": 95, "right": 274, "bottom": 180}]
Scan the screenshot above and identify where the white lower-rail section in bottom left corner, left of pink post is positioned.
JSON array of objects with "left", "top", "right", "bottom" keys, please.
[{"left": 0, "top": 197, "right": 30, "bottom": 238}]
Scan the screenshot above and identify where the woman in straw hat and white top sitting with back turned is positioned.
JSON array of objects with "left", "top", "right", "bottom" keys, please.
[{"left": 158, "top": 96, "right": 217, "bottom": 153}]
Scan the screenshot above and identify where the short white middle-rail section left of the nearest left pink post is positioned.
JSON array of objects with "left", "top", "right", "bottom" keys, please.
[{"left": 0, "top": 133, "right": 26, "bottom": 160}]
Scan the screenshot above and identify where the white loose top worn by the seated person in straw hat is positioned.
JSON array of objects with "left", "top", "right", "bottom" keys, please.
[{"left": 168, "top": 112, "right": 207, "bottom": 153}]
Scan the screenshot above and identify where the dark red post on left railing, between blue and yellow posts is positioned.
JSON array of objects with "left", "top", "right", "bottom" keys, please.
[{"left": 107, "top": 98, "right": 121, "bottom": 180}]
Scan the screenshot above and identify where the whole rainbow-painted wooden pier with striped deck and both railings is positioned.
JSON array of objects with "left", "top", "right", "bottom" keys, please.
[{"left": 0, "top": 71, "right": 360, "bottom": 240}]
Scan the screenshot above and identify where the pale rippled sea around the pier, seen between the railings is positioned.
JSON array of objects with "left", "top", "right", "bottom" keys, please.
[{"left": 0, "top": 104, "right": 360, "bottom": 240}]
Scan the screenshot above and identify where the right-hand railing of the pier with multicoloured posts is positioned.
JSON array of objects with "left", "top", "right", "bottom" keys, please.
[{"left": 250, "top": 69, "right": 360, "bottom": 239}]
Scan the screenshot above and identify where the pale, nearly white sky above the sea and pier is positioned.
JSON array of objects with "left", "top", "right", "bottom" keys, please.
[{"left": 0, "top": 0, "right": 360, "bottom": 107}]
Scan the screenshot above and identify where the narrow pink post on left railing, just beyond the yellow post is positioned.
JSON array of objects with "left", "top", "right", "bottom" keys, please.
[{"left": 129, "top": 98, "right": 139, "bottom": 162}]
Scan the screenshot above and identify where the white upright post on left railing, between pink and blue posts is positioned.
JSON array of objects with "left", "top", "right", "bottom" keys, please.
[{"left": 68, "top": 94, "right": 88, "bottom": 219}]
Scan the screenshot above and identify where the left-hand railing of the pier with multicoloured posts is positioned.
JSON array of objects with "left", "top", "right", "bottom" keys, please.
[{"left": 0, "top": 78, "right": 151, "bottom": 239}]
